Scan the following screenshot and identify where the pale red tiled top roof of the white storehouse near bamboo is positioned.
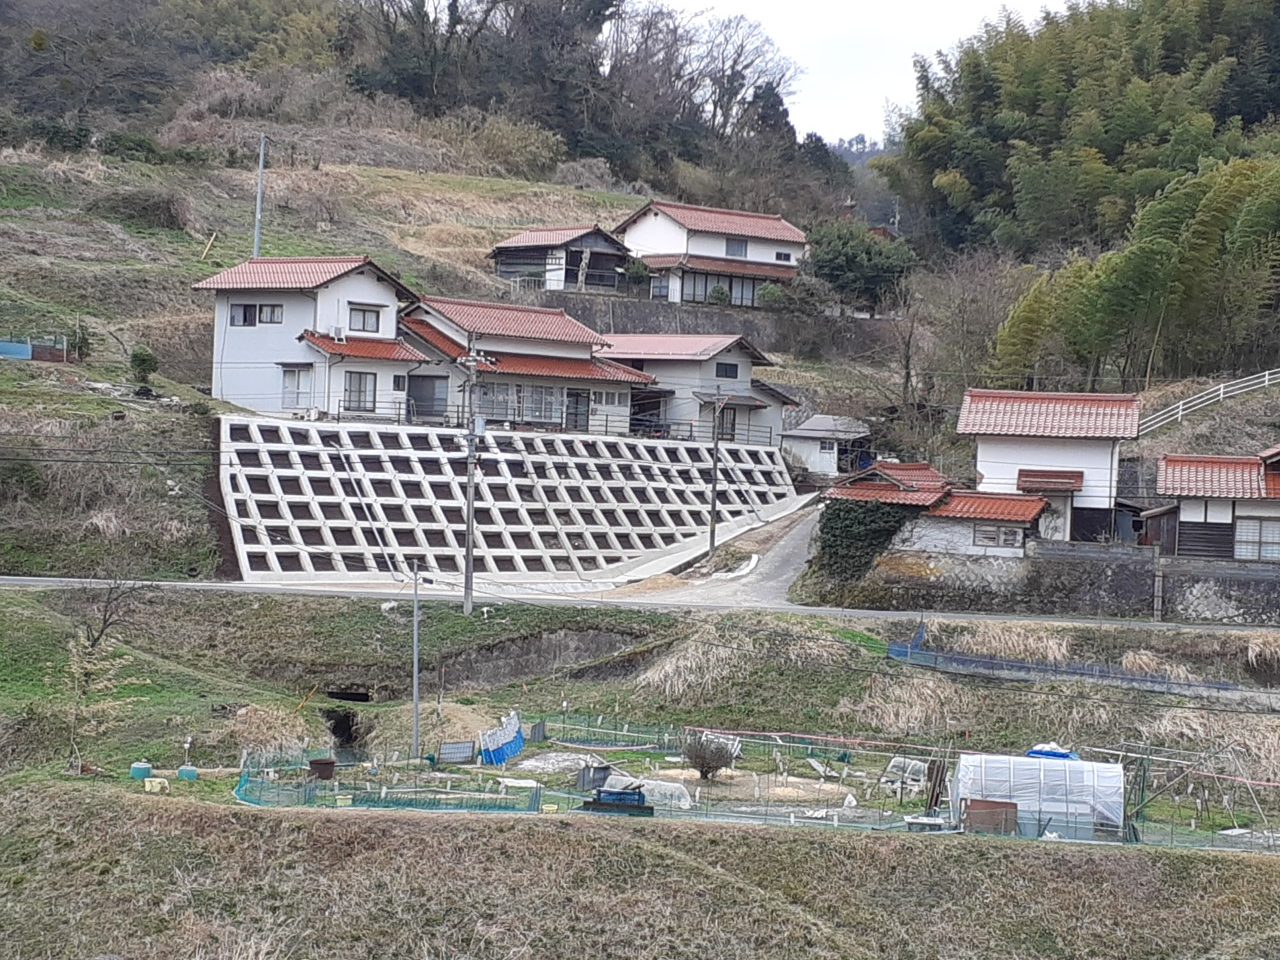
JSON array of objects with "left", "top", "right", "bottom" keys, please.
[{"left": 956, "top": 390, "right": 1142, "bottom": 440}]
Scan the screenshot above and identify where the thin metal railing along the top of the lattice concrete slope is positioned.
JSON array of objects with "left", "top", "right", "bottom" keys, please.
[{"left": 325, "top": 399, "right": 777, "bottom": 447}]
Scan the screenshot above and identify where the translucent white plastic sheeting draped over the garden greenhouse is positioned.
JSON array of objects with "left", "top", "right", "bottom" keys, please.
[{"left": 951, "top": 754, "right": 1124, "bottom": 827}]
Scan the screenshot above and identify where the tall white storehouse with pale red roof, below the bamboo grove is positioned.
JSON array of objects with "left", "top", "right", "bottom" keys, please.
[{"left": 956, "top": 389, "right": 1142, "bottom": 540}]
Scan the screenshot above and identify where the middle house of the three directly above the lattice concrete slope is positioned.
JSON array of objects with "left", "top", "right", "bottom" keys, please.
[{"left": 401, "top": 297, "right": 653, "bottom": 434}]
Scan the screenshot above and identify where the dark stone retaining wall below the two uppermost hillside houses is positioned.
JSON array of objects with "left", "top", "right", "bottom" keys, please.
[{"left": 521, "top": 291, "right": 892, "bottom": 357}]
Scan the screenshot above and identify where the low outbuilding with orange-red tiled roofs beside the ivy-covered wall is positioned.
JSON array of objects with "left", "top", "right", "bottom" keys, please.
[{"left": 823, "top": 462, "right": 1048, "bottom": 557}]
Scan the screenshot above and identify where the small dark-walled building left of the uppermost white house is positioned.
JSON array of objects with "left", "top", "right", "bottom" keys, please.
[{"left": 489, "top": 224, "right": 628, "bottom": 292}]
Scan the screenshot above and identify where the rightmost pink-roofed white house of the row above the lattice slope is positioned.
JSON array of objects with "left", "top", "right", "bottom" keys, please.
[{"left": 600, "top": 334, "right": 796, "bottom": 447}]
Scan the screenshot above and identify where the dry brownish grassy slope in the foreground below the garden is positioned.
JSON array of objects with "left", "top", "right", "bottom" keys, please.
[{"left": 0, "top": 786, "right": 1280, "bottom": 960}]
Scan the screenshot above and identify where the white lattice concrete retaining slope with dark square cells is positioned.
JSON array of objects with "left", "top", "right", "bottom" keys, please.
[{"left": 219, "top": 416, "right": 808, "bottom": 588}]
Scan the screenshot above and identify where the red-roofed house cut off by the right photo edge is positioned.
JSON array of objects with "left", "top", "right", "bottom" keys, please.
[{"left": 1144, "top": 447, "right": 1280, "bottom": 563}]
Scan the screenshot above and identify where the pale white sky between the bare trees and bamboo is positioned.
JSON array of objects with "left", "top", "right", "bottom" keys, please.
[{"left": 667, "top": 0, "right": 1066, "bottom": 141}]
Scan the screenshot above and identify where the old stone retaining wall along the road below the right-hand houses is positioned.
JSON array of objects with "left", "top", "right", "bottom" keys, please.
[{"left": 827, "top": 540, "right": 1280, "bottom": 625}]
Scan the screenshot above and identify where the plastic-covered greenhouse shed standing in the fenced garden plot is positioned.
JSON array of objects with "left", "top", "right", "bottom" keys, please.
[{"left": 951, "top": 754, "right": 1124, "bottom": 840}]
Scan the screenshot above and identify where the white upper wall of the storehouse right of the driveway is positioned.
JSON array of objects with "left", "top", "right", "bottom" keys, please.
[{"left": 978, "top": 436, "right": 1120, "bottom": 509}]
